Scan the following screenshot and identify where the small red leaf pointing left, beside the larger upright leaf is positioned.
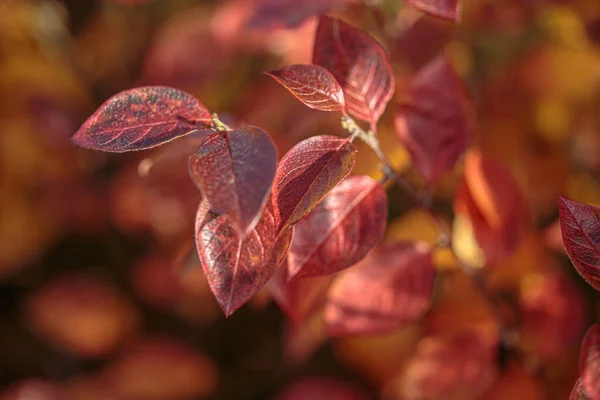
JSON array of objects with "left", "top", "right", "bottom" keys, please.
[{"left": 265, "top": 64, "right": 345, "bottom": 111}]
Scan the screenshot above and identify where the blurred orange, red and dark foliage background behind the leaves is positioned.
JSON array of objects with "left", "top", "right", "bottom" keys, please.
[{"left": 0, "top": 0, "right": 600, "bottom": 400}]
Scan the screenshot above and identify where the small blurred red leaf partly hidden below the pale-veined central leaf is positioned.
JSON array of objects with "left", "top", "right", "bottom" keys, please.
[{"left": 267, "top": 262, "right": 335, "bottom": 326}]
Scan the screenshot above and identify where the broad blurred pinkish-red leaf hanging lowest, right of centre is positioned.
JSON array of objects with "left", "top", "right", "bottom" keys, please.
[{"left": 325, "top": 242, "right": 436, "bottom": 335}]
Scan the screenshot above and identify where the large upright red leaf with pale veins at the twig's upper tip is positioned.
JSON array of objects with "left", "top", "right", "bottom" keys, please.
[{"left": 313, "top": 15, "right": 394, "bottom": 128}]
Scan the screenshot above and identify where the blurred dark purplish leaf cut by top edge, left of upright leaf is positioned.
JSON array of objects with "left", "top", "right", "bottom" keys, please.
[{"left": 247, "top": 0, "right": 356, "bottom": 29}]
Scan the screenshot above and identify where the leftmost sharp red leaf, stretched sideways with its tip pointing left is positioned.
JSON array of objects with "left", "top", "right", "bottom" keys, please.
[{"left": 72, "top": 86, "right": 211, "bottom": 152}]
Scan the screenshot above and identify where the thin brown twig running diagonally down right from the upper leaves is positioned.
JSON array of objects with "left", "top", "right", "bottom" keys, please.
[{"left": 341, "top": 116, "right": 523, "bottom": 358}]
